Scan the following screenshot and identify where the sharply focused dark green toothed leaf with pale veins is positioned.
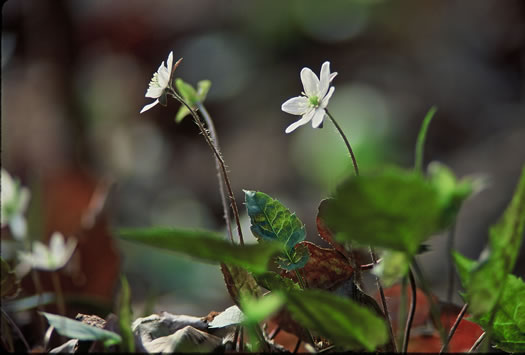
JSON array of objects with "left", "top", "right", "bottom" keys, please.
[{"left": 244, "top": 190, "right": 309, "bottom": 271}]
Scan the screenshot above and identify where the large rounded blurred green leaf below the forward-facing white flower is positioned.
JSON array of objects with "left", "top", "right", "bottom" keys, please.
[{"left": 325, "top": 167, "right": 443, "bottom": 255}]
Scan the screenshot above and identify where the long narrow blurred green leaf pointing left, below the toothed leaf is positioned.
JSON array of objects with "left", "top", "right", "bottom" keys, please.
[{"left": 118, "top": 228, "right": 280, "bottom": 273}]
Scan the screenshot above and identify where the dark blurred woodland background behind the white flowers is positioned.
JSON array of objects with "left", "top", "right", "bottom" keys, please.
[{"left": 1, "top": 0, "right": 525, "bottom": 322}]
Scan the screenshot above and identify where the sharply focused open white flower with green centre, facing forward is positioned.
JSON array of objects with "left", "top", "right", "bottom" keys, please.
[{"left": 281, "top": 61, "right": 337, "bottom": 133}]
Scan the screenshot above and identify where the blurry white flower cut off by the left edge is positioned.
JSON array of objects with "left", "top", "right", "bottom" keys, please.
[{"left": 0, "top": 169, "right": 31, "bottom": 240}]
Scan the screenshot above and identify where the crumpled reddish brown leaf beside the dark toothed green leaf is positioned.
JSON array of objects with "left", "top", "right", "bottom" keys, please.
[{"left": 281, "top": 241, "right": 354, "bottom": 290}]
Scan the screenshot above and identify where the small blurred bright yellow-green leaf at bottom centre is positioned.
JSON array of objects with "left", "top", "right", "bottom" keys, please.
[{"left": 241, "top": 291, "right": 286, "bottom": 324}]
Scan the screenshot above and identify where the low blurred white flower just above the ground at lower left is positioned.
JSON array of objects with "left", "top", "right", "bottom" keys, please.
[{"left": 18, "top": 232, "right": 77, "bottom": 271}]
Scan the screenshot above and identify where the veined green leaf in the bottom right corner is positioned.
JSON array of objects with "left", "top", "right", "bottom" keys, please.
[{"left": 473, "top": 274, "right": 525, "bottom": 352}]
